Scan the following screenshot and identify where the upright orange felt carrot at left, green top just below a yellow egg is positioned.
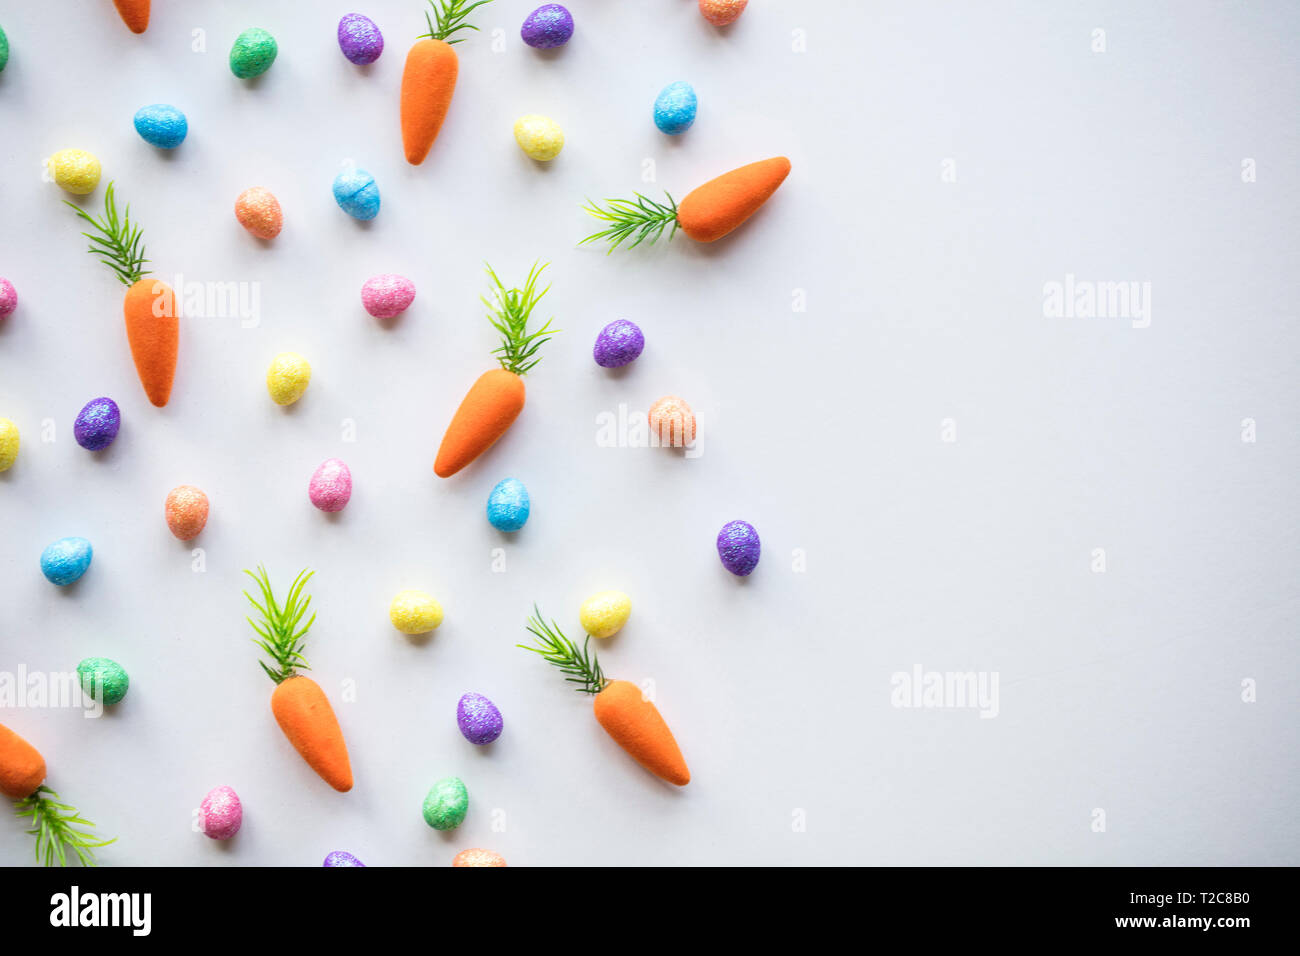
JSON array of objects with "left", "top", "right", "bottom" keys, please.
[{"left": 64, "top": 183, "right": 181, "bottom": 408}]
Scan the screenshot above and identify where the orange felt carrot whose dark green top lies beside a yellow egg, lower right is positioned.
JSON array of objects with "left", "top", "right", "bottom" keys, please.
[{"left": 516, "top": 605, "right": 690, "bottom": 787}]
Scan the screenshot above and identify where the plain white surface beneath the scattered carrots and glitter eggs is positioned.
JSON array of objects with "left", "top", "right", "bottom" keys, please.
[{"left": 0, "top": 0, "right": 1300, "bottom": 865}]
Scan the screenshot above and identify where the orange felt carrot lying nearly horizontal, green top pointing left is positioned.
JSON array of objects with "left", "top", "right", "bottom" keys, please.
[{"left": 579, "top": 156, "right": 790, "bottom": 252}]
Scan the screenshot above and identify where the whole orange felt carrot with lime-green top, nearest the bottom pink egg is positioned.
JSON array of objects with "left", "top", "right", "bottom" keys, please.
[{"left": 244, "top": 566, "right": 352, "bottom": 793}]
